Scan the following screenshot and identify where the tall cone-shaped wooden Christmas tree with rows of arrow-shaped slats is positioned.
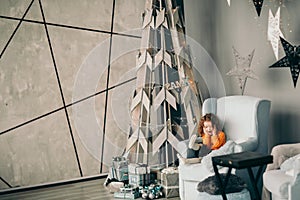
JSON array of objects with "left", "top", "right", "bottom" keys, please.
[{"left": 126, "top": 0, "right": 201, "bottom": 165}]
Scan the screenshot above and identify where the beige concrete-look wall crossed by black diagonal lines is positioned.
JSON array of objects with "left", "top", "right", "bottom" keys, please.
[{"left": 0, "top": 0, "right": 145, "bottom": 189}]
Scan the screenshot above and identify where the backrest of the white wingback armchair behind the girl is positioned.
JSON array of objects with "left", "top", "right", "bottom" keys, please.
[{"left": 202, "top": 95, "right": 271, "bottom": 153}]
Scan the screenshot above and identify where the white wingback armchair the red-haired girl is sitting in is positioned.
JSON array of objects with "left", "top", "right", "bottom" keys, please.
[{"left": 178, "top": 96, "right": 271, "bottom": 200}]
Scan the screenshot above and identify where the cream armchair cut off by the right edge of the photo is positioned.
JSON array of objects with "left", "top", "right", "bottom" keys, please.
[{"left": 262, "top": 143, "right": 300, "bottom": 200}]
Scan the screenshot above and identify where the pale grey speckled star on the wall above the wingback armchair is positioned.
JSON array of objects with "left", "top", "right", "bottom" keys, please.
[{"left": 226, "top": 47, "right": 258, "bottom": 95}]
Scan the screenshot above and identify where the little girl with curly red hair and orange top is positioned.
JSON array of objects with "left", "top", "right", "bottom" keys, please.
[{"left": 177, "top": 113, "right": 226, "bottom": 164}]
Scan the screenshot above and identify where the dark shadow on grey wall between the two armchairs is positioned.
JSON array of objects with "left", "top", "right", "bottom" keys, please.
[{"left": 269, "top": 111, "right": 300, "bottom": 149}]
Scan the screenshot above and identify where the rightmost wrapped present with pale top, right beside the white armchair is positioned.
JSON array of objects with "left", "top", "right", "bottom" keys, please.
[{"left": 157, "top": 167, "right": 179, "bottom": 187}]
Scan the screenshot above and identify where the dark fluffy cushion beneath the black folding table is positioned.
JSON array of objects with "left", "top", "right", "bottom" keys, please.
[{"left": 197, "top": 174, "right": 247, "bottom": 195}]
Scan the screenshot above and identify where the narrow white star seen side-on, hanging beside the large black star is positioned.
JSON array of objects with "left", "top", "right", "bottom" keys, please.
[{"left": 268, "top": 7, "right": 283, "bottom": 60}]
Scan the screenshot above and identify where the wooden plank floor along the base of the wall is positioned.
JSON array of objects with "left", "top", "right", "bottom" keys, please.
[{"left": 0, "top": 179, "right": 180, "bottom": 200}]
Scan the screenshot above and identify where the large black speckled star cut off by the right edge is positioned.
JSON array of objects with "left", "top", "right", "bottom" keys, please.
[{"left": 270, "top": 37, "right": 300, "bottom": 88}]
